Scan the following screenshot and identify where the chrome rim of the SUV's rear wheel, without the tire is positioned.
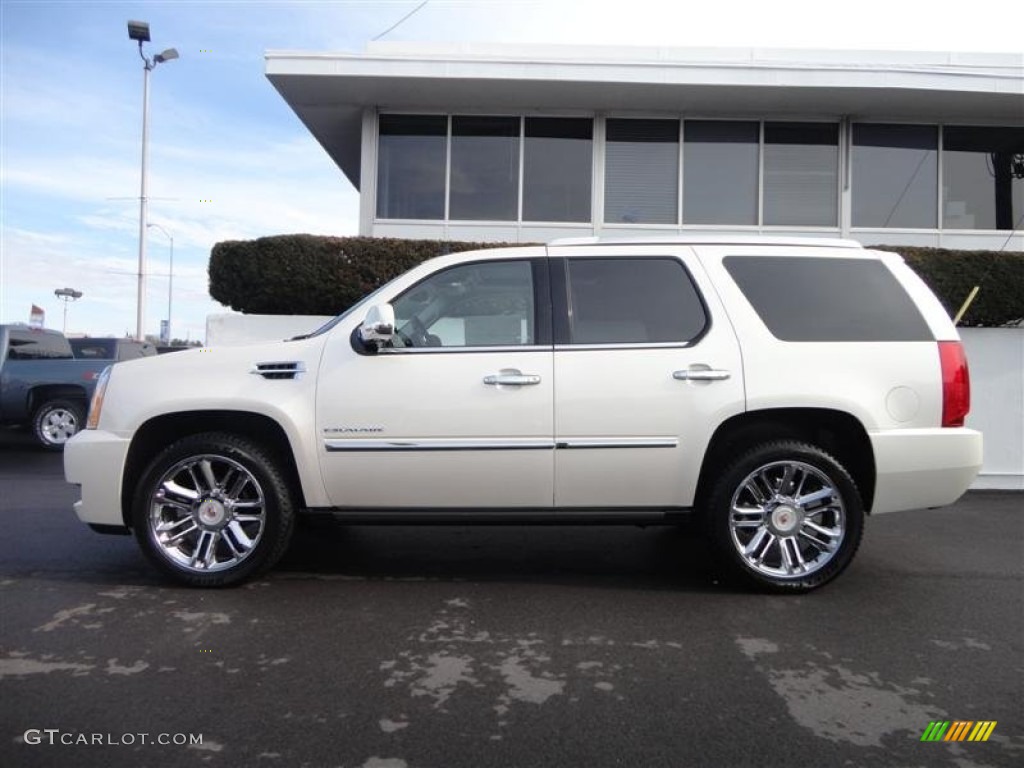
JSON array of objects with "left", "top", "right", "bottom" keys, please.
[{"left": 729, "top": 461, "right": 847, "bottom": 580}]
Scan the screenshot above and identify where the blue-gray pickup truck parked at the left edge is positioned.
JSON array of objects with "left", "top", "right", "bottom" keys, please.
[{"left": 0, "top": 326, "right": 111, "bottom": 451}]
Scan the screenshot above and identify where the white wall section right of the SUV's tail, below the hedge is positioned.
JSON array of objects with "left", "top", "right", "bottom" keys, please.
[{"left": 959, "top": 328, "right": 1024, "bottom": 490}]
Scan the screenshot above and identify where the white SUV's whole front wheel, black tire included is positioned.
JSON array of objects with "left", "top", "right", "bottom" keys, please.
[{"left": 132, "top": 432, "right": 295, "bottom": 587}]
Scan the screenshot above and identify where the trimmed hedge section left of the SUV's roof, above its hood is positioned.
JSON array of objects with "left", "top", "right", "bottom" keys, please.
[{"left": 209, "top": 234, "right": 506, "bottom": 314}]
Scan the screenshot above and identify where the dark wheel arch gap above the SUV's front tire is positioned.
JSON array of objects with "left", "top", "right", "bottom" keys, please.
[{"left": 121, "top": 410, "right": 305, "bottom": 527}]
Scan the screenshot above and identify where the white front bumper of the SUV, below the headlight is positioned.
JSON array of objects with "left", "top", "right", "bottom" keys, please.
[{"left": 63, "top": 429, "right": 131, "bottom": 526}]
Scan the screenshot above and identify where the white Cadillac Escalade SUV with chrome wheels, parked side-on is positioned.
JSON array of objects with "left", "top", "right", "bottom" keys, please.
[{"left": 65, "top": 238, "right": 982, "bottom": 592}]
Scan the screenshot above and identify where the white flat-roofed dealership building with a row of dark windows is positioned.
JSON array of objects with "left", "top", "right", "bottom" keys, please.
[{"left": 266, "top": 42, "right": 1024, "bottom": 250}]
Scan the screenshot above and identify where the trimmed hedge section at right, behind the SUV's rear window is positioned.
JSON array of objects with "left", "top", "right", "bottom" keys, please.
[{"left": 871, "top": 246, "right": 1024, "bottom": 327}]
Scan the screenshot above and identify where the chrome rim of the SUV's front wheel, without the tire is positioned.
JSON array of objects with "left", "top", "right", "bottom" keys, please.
[{"left": 147, "top": 454, "right": 267, "bottom": 573}]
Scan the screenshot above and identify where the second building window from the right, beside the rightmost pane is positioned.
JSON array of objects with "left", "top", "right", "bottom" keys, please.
[{"left": 851, "top": 123, "right": 939, "bottom": 229}]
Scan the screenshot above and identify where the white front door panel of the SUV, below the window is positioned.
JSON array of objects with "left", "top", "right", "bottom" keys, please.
[{"left": 316, "top": 345, "right": 553, "bottom": 508}]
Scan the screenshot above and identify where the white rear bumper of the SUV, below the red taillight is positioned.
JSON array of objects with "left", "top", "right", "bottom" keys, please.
[{"left": 868, "top": 428, "right": 982, "bottom": 514}]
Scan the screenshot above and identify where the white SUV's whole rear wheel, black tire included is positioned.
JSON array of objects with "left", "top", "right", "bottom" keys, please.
[{"left": 702, "top": 440, "right": 864, "bottom": 594}]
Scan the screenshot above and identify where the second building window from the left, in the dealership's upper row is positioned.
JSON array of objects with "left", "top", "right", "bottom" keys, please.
[{"left": 449, "top": 117, "right": 519, "bottom": 221}]
